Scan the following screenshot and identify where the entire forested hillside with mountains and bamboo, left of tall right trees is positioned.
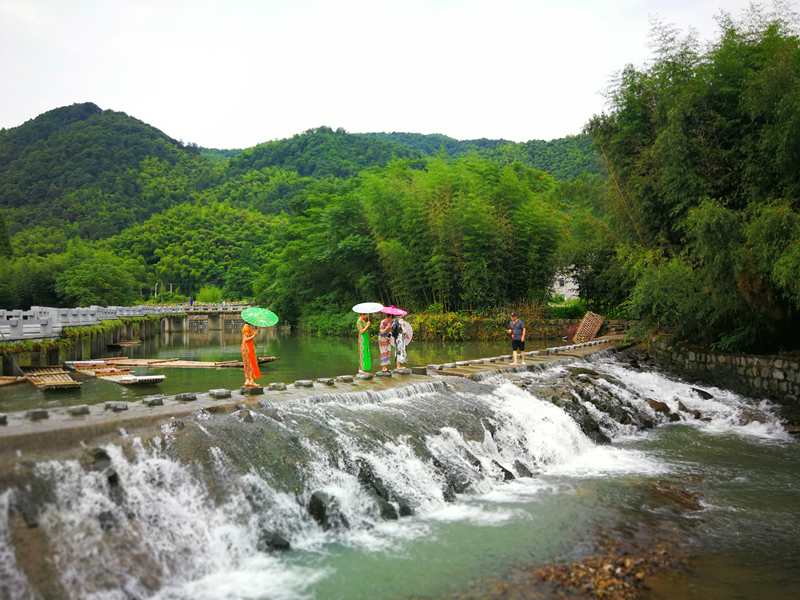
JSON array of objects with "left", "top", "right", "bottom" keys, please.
[{"left": 0, "top": 103, "right": 608, "bottom": 322}]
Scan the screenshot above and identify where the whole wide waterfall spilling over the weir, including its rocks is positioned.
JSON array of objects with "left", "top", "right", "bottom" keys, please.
[{"left": 0, "top": 357, "right": 782, "bottom": 600}]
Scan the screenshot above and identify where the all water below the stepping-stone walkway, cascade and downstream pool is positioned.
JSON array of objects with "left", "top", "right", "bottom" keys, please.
[{"left": 0, "top": 340, "right": 800, "bottom": 600}]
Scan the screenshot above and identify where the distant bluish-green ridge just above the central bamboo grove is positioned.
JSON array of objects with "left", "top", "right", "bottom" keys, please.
[{"left": 362, "top": 133, "right": 605, "bottom": 179}]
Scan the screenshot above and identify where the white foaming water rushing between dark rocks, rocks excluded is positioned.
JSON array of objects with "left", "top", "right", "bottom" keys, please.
[{"left": 0, "top": 358, "right": 785, "bottom": 600}]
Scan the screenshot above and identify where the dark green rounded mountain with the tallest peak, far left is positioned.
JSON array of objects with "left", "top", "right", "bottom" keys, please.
[{"left": 0, "top": 103, "right": 222, "bottom": 239}]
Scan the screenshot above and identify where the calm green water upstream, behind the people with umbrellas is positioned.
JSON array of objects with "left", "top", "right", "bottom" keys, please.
[{"left": 0, "top": 328, "right": 554, "bottom": 412}]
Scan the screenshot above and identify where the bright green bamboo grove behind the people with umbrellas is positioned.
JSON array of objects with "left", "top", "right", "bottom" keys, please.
[{"left": 256, "top": 158, "right": 564, "bottom": 321}]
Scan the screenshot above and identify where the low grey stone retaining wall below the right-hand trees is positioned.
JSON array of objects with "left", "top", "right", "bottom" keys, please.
[{"left": 650, "top": 337, "right": 800, "bottom": 404}]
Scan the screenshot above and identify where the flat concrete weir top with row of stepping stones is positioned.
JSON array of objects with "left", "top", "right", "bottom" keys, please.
[{"left": 0, "top": 335, "right": 627, "bottom": 460}]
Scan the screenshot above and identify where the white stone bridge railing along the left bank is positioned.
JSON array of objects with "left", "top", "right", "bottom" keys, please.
[{"left": 0, "top": 304, "right": 250, "bottom": 342}]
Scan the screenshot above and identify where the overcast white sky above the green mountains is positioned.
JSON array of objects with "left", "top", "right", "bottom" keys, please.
[{"left": 0, "top": 0, "right": 796, "bottom": 148}]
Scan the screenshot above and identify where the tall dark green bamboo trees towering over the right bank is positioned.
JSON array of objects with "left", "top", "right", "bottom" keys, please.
[{"left": 587, "top": 7, "right": 800, "bottom": 350}]
